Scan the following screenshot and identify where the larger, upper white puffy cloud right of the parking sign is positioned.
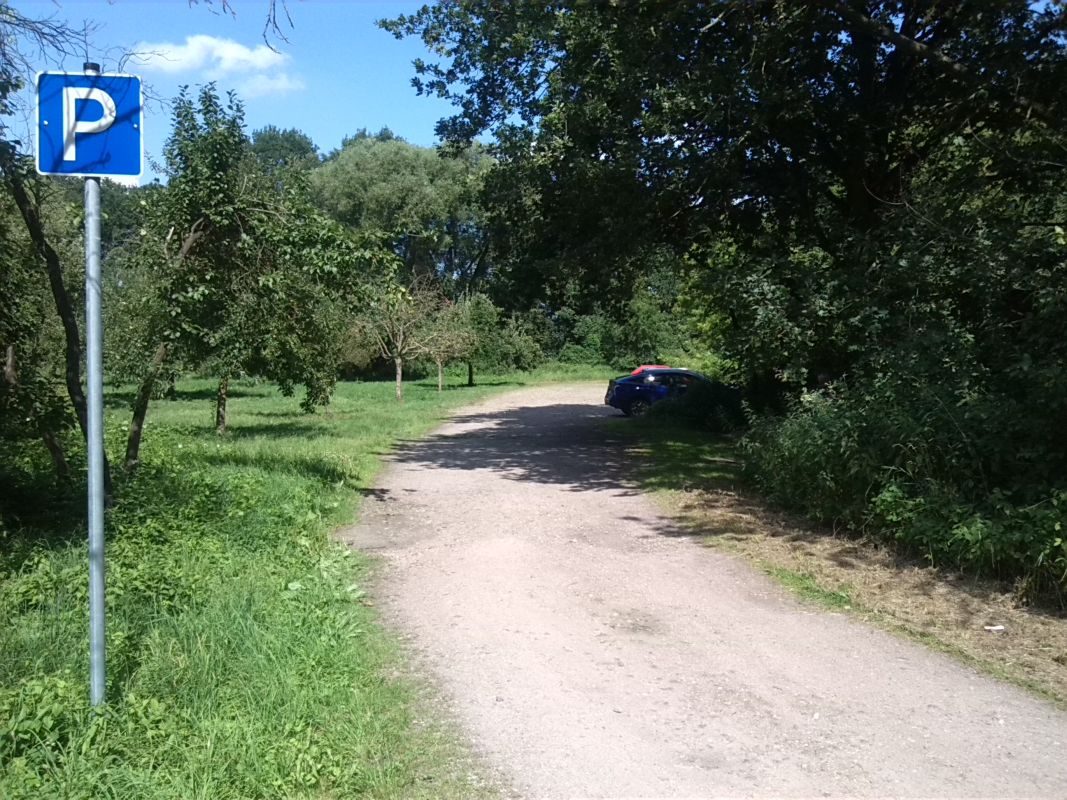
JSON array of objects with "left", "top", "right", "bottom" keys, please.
[{"left": 130, "top": 34, "right": 289, "bottom": 78}]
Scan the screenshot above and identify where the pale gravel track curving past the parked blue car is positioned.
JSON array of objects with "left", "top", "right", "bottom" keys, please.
[{"left": 346, "top": 384, "right": 1067, "bottom": 798}]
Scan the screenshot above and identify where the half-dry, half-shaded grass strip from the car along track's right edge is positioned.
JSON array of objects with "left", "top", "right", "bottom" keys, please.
[{"left": 609, "top": 418, "right": 1067, "bottom": 707}]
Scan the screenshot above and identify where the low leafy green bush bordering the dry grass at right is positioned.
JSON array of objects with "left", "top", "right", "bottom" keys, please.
[{"left": 744, "top": 377, "right": 1067, "bottom": 596}]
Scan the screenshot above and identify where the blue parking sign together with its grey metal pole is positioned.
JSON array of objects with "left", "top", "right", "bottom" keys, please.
[{"left": 37, "top": 63, "right": 142, "bottom": 706}]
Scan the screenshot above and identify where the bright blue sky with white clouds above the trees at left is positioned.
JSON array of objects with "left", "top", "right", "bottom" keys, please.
[{"left": 13, "top": 0, "right": 451, "bottom": 181}]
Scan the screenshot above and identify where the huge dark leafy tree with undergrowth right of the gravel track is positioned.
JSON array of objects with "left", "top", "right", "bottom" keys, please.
[{"left": 394, "top": 0, "right": 1067, "bottom": 591}]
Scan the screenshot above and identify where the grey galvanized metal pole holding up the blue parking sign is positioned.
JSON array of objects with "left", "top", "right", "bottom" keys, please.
[{"left": 84, "top": 63, "right": 106, "bottom": 706}]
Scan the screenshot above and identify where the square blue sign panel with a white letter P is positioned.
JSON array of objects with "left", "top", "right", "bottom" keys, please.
[{"left": 37, "top": 73, "right": 142, "bottom": 177}]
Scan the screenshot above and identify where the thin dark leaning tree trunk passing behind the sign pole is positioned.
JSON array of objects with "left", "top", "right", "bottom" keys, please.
[{"left": 3, "top": 160, "right": 111, "bottom": 505}]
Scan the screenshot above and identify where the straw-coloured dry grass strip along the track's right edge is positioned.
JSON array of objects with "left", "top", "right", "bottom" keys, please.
[{"left": 657, "top": 480, "right": 1067, "bottom": 707}]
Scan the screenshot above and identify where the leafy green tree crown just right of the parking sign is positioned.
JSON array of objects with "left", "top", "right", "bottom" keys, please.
[{"left": 132, "top": 85, "right": 393, "bottom": 411}]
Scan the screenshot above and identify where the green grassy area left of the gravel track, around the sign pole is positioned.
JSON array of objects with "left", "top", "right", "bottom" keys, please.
[{"left": 0, "top": 368, "right": 603, "bottom": 800}]
